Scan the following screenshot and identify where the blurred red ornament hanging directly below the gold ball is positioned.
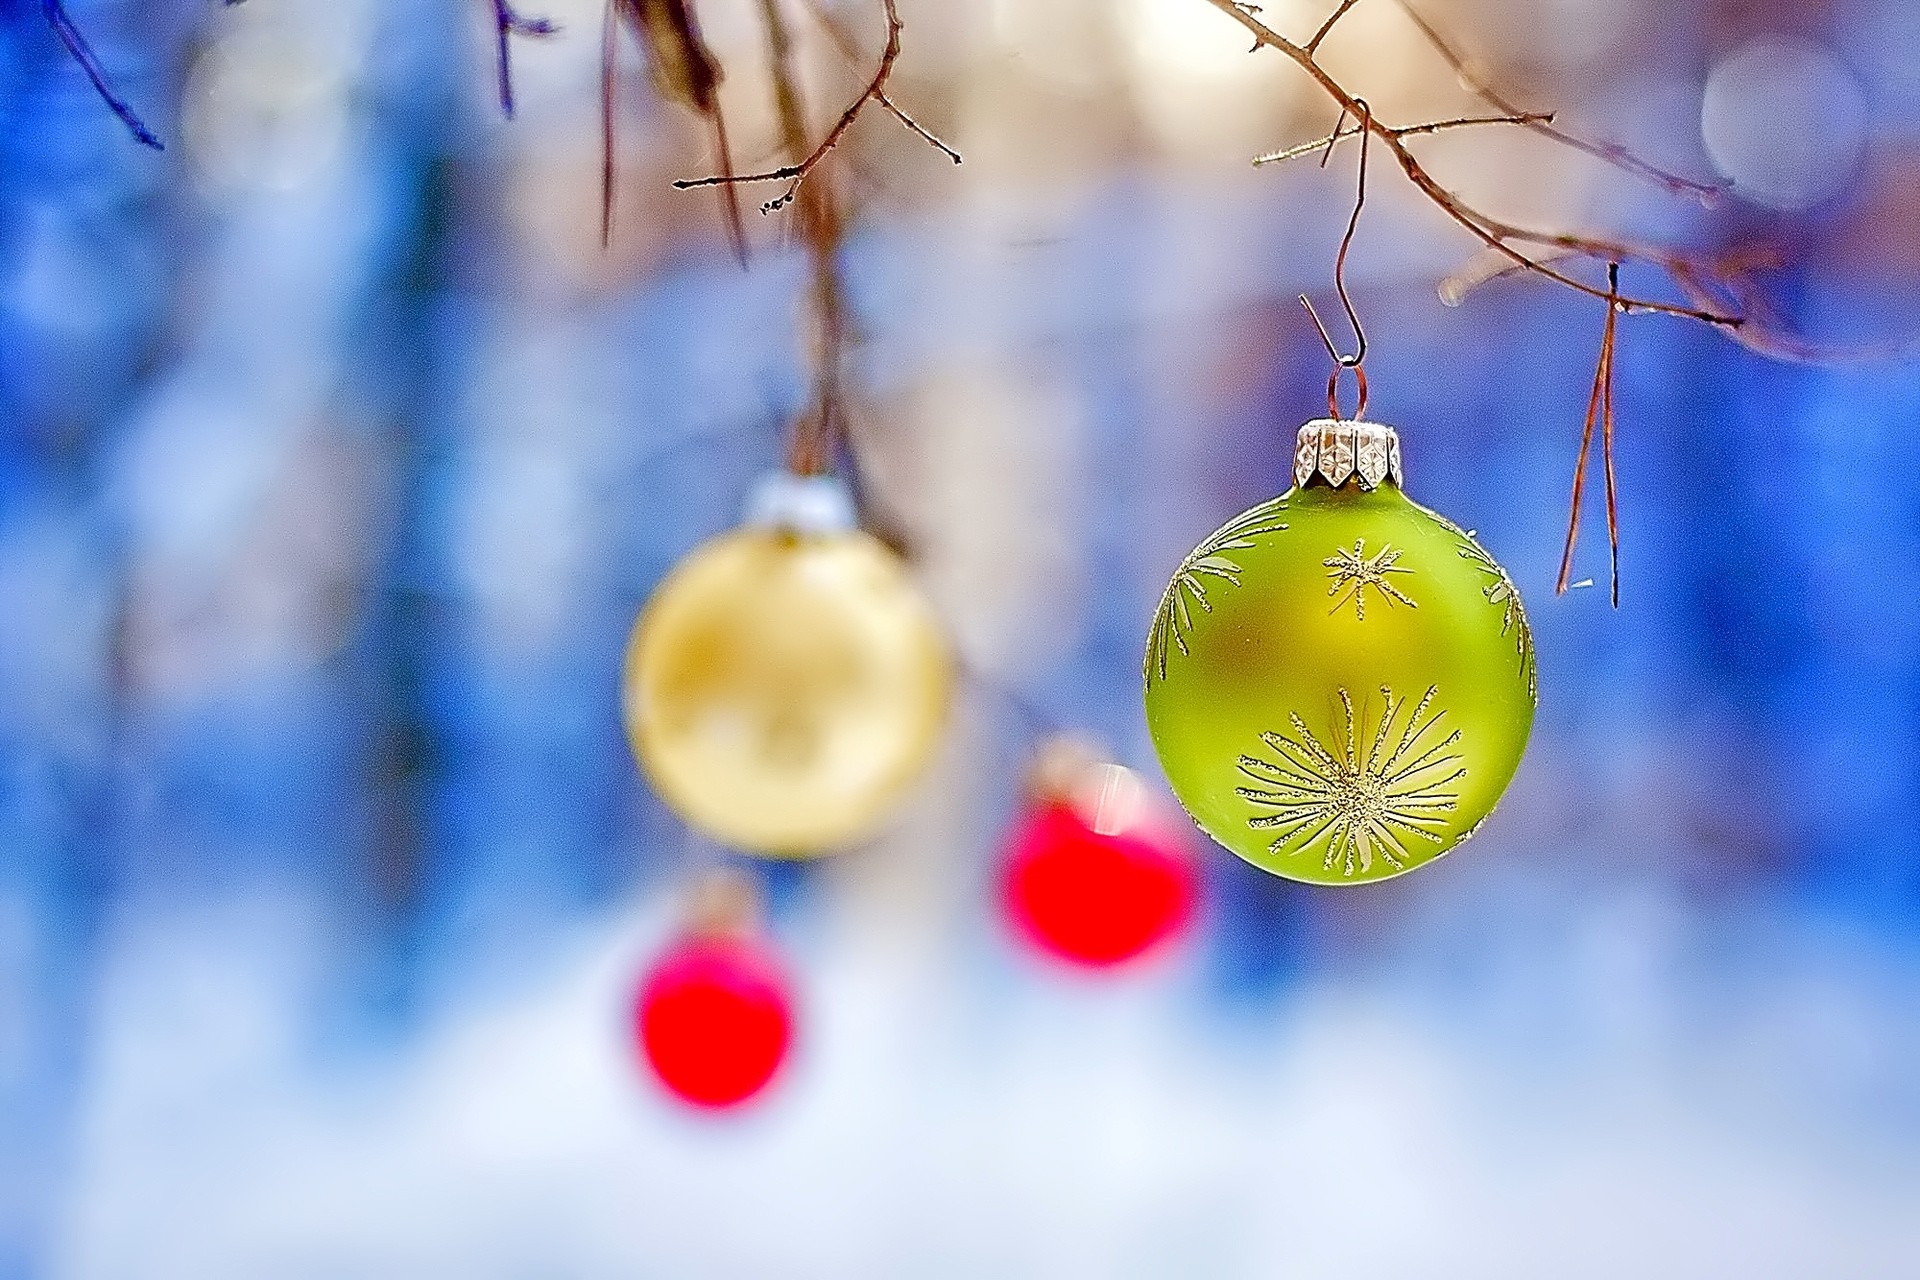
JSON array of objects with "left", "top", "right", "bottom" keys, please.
[{"left": 634, "top": 886, "right": 793, "bottom": 1109}]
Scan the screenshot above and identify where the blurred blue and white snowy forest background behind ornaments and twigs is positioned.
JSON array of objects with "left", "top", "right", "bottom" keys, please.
[{"left": 0, "top": 0, "right": 1920, "bottom": 1280}]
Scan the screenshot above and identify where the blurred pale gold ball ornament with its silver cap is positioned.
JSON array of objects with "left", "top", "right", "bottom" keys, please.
[{"left": 626, "top": 476, "right": 952, "bottom": 858}]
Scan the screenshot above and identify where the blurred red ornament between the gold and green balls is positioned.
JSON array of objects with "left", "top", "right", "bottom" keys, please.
[{"left": 1002, "top": 744, "right": 1194, "bottom": 967}]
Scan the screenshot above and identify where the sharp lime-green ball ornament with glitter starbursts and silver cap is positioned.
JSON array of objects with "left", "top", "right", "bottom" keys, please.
[{"left": 1144, "top": 420, "right": 1536, "bottom": 885}]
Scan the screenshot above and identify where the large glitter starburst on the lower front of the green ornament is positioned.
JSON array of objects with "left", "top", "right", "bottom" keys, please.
[{"left": 1235, "top": 685, "right": 1467, "bottom": 875}]
